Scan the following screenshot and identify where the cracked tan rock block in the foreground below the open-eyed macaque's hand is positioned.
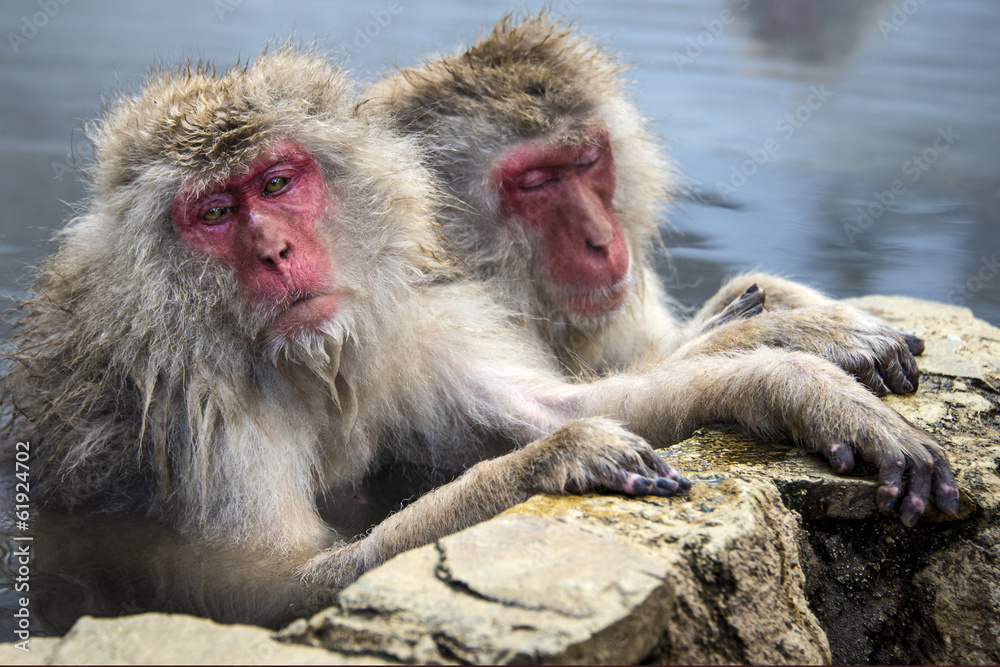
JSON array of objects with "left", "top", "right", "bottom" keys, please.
[{"left": 283, "top": 479, "right": 830, "bottom": 664}]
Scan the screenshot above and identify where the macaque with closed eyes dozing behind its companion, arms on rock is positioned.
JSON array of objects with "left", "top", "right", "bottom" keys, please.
[{"left": 367, "top": 14, "right": 922, "bottom": 394}]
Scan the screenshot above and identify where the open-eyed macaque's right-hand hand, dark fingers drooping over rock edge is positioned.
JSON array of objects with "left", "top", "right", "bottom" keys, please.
[{"left": 800, "top": 397, "right": 958, "bottom": 527}]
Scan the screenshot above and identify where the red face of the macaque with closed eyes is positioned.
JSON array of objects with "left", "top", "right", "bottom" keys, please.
[{"left": 492, "top": 128, "right": 629, "bottom": 317}]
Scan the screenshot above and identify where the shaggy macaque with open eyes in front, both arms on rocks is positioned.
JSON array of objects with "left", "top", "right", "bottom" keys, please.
[{"left": 0, "top": 45, "right": 957, "bottom": 622}]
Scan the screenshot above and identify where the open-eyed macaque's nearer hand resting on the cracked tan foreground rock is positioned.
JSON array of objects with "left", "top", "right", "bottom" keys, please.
[{"left": 515, "top": 418, "right": 691, "bottom": 496}]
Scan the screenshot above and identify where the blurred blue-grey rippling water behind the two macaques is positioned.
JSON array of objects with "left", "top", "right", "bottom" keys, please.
[{"left": 0, "top": 0, "right": 1000, "bottom": 330}]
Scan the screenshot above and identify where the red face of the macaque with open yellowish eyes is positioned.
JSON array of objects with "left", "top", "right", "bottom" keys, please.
[{"left": 171, "top": 141, "right": 339, "bottom": 339}]
